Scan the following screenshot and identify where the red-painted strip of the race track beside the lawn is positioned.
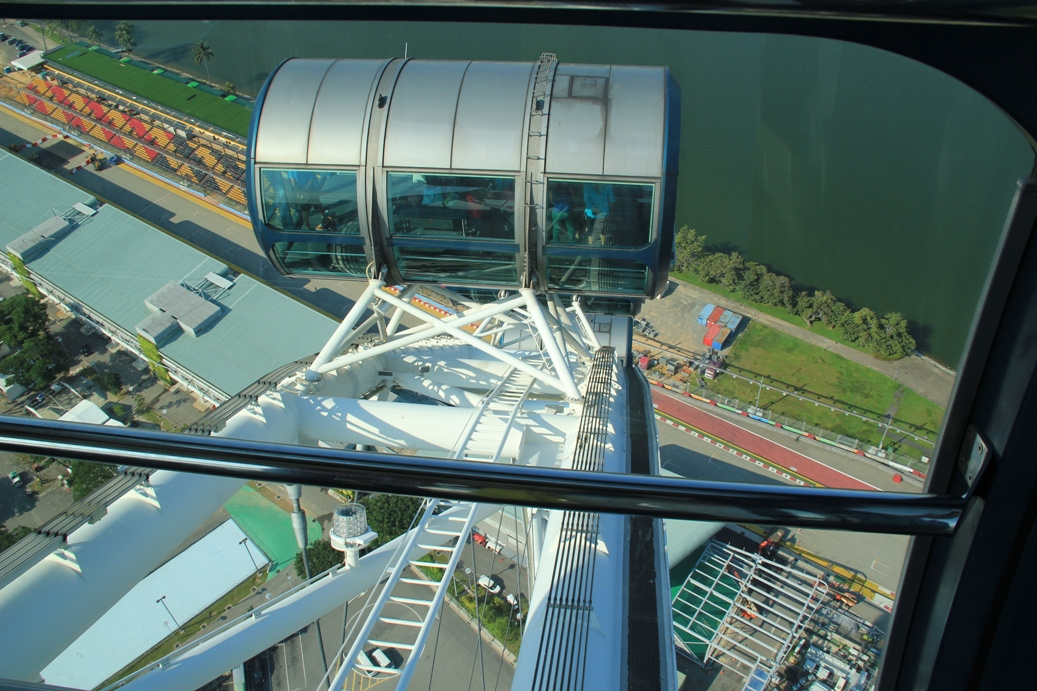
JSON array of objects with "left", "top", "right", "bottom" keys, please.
[{"left": 651, "top": 388, "right": 878, "bottom": 490}]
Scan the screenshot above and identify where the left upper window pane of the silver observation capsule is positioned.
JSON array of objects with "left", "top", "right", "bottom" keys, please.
[{"left": 259, "top": 168, "right": 360, "bottom": 234}]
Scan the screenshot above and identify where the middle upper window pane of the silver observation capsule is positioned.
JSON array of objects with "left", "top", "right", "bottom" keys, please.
[{"left": 389, "top": 173, "right": 515, "bottom": 240}]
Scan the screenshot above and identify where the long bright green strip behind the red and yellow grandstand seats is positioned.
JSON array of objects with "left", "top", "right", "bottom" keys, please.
[{"left": 47, "top": 46, "right": 252, "bottom": 137}]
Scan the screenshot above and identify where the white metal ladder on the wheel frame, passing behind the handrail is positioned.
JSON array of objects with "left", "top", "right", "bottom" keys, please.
[{"left": 332, "top": 368, "right": 536, "bottom": 689}]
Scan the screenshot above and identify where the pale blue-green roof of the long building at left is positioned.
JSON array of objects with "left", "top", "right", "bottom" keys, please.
[{"left": 0, "top": 151, "right": 335, "bottom": 394}]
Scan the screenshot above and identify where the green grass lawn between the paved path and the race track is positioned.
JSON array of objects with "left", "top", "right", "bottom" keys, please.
[{"left": 707, "top": 323, "right": 944, "bottom": 457}]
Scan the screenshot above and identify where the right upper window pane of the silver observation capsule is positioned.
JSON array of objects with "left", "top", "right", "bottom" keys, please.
[{"left": 544, "top": 179, "right": 654, "bottom": 248}]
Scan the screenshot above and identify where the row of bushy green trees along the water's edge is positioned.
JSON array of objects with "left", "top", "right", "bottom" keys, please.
[{"left": 674, "top": 225, "right": 916, "bottom": 360}]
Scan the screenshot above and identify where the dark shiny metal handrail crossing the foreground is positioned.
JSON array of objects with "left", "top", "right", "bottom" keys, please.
[{"left": 0, "top": 417, "right": 965, "bottom": 535}]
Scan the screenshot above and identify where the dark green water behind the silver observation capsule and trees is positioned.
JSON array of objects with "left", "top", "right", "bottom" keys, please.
[{"left": 97, "top": 20, "right": 1033, "bottom": 366}]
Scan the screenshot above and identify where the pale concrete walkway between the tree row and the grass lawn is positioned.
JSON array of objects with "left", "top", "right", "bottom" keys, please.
[{"left": 641, "top": 279, "right": 955, "bottom": 408}]
